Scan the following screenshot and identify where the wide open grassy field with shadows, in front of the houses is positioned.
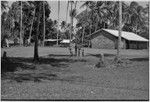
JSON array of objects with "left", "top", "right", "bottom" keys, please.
[{"left": 1, "top": 47, "right": 149, "bottom": 100}]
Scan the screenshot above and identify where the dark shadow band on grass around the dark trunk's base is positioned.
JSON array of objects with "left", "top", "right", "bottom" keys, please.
[{"left": 1, "top": 57, "right": 86, "bottom": 73}]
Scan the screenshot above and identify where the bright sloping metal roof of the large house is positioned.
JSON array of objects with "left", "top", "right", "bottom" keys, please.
[{"left": 102, "top": 29, "right": 148, "bottom": 42}]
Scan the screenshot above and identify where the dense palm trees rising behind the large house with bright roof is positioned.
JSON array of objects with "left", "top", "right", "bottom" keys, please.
[{"left": 76, "top": 1, "right": 149, "bottom": 39}]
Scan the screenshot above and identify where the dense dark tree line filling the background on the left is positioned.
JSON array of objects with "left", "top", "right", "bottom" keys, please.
[{"left": 1, "top": 1, "right": 71, "bottom": 45}]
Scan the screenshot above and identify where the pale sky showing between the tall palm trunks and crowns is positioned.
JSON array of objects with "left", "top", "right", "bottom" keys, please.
[{"left": 8, "top": 1, "right": 147, "bottom": 25}]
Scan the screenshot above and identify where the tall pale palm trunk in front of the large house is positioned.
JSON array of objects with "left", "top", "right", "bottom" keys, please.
[{"left": 117, "top": 1, "right": 122, "bottom": 60}]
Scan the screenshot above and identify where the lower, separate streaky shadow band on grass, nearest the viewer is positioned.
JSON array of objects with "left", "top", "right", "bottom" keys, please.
[{"left": 2, "top": 73, "right": 84, "bottom": 83}]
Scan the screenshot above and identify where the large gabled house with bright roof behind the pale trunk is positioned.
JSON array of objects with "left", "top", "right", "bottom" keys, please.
[{"left": 87, "top": 29, "right": 148, "bottom": 49}]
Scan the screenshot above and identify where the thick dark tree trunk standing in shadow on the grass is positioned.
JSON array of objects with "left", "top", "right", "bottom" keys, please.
[{"left": 33, "top": 5, "right": 41, "bottom": 62}]
